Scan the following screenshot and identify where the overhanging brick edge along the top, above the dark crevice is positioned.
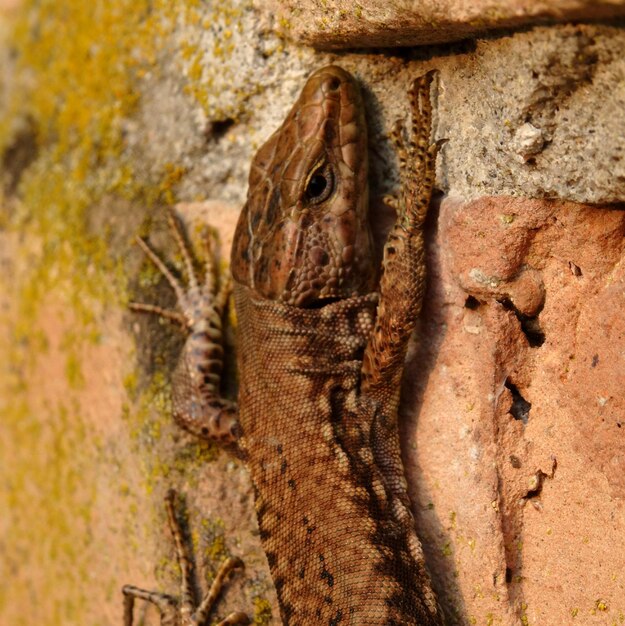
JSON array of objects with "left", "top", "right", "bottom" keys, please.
[{"left": 256, "top": 0, "right": 625, "bottom": 49}]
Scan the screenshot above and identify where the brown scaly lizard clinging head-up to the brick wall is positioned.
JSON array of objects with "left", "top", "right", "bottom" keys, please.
[{"left": 125, "top": 66, "right": 443, "bottom": 626}]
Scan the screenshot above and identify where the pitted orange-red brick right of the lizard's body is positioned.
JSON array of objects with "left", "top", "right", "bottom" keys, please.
[{"left": 406, "top": 197, "right": 625, "bottom": 626}]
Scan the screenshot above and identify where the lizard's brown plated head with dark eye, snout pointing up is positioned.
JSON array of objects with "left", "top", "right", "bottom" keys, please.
[{"left": 231, "top": 66, "right": 375, "bottom": 307}]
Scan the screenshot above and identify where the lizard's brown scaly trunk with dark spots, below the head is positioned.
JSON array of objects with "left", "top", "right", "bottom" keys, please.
[{"left": 235, "top": 286, "right": 428, "bottom": 626}]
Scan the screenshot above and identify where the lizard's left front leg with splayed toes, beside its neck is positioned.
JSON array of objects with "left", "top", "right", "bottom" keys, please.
[{"left": 129, "top": 212, "right": 238, "bottom": 444}]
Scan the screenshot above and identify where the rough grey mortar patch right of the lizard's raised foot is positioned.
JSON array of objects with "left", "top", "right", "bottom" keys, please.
[{"left": 436, "top": 25, "right": 625, "bottom": 203}]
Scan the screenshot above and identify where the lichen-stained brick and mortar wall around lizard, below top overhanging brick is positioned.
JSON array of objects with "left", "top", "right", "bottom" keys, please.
[{"left": 0, "top": 0, "right": 625, "bottom": 626}]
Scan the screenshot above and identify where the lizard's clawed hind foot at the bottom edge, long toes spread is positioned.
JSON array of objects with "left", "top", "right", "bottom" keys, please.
[{"left": 122, "top": 489, "right": 250, "bottom": 626}]
